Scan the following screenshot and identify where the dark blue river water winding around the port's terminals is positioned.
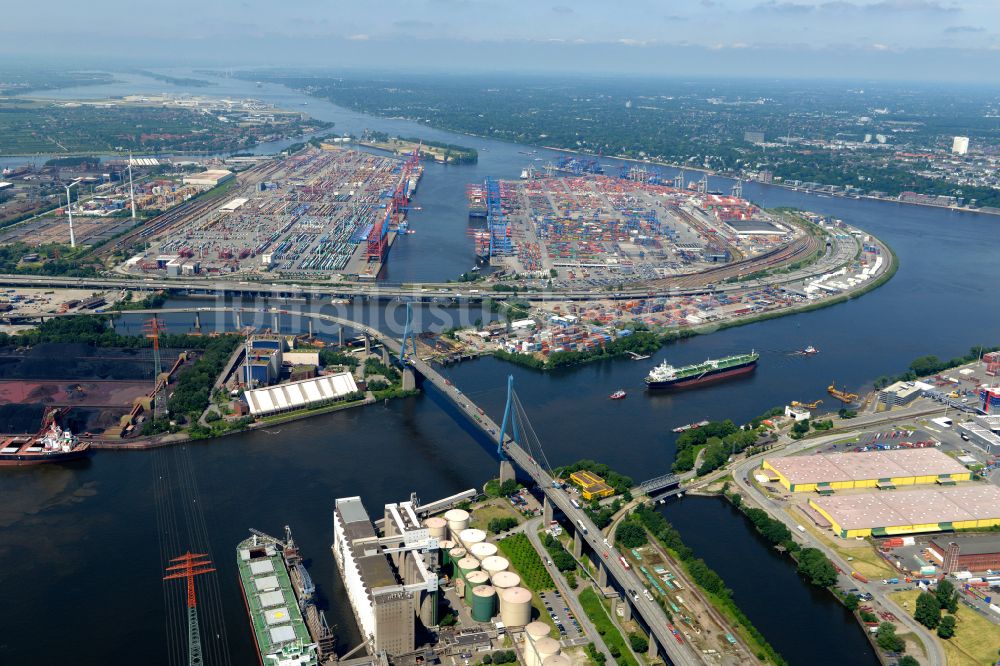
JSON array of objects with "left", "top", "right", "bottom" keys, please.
[{"left": 0, "top": 72, "right": 1000, "bottom": 664}]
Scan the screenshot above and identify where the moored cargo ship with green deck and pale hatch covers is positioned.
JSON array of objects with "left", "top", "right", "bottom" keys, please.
[{"left": 236, "top": 526, "right": 337, "bottom": 666}]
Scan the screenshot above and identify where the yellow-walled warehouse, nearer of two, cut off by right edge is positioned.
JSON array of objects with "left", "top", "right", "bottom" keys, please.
[{"left": 809, "top": 484, "right": 1000, "bottom": 539}]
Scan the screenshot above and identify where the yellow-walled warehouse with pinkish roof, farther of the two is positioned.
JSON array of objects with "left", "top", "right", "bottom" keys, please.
[{"left": 764, "top": 448, "right": 971, "bottom": 494}]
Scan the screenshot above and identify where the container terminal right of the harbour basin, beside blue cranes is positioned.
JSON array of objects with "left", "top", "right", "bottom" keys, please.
[{"left": 468, "top": 173, "right": 804, "bottom": 282}]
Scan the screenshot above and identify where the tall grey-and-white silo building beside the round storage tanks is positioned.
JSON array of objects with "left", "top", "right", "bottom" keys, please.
[{"left": 333, "top": 497, "right": 439, "bottom": 656}]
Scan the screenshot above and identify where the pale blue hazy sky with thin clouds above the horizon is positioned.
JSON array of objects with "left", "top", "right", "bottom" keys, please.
[{"left": 0, "top": 0, "right": 1000, "bottom": 83}]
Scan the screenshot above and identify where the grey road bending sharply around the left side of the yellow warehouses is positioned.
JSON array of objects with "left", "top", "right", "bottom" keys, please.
[{"left": 732, "top": 428, "right": 946, "bottom": 666}]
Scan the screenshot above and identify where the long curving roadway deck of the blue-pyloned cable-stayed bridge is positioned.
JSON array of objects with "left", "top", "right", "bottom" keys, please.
[{"left": 64, "top": 307, "right": 703, "bottom": 666}]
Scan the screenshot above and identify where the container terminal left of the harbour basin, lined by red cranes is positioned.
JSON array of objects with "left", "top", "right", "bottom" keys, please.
[{"left": 120, "top": 147, "right": 423, "bottom": 279}]
